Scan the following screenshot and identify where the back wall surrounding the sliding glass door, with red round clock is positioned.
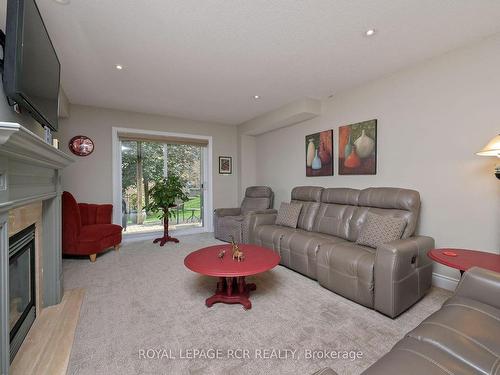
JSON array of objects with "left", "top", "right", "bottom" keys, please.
[{"left": 58, "top": 105, "right": 238, "bottom": 208}]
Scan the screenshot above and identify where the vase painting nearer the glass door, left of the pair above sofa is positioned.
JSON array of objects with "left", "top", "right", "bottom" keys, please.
[{"left": 306, "top": 130, "right": 333, "bottom": 177}]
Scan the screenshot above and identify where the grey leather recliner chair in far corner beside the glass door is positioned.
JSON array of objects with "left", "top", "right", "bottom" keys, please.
[{"left": 214, "top": 186, "right": 276, "bottom": 243}]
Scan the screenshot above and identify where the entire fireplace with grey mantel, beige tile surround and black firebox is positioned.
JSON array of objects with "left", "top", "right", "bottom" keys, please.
[{"left": 0, "top": 122, "right": 73, "bottom": 375}]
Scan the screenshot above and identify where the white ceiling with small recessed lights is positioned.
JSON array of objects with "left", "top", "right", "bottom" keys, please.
[{"left": 37, "top": 0, "right": 500, "bottom": 124}]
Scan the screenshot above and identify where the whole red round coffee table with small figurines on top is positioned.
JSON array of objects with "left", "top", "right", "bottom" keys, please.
[{"left": 184, "top": 244, "right": 280, "bottom": 310}]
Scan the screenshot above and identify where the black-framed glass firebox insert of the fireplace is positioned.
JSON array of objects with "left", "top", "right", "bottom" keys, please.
[{"left": 9, "top": 225, "right": 36, "bottom": 362}]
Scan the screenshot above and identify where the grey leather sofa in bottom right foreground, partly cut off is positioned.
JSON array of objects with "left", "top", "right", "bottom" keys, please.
[{"left": 315, "top": 267, "right": 500, "bottom": 375}]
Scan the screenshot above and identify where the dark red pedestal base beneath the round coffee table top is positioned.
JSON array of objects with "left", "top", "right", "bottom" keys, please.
[{"left": 205, "top": 276, "right": 257, "bottom": 310}]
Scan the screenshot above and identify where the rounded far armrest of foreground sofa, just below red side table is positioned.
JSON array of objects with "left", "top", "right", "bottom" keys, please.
[{"left": 455, "top": 267, "right": 500, "bottom": 309}]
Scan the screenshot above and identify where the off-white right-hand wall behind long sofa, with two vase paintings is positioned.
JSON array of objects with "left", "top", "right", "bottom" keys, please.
[{"left": 256, "top": 35, "right": 500, "bottom": 284}]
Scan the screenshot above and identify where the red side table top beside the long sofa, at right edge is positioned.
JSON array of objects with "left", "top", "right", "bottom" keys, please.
[{"left": 427, "top": 248, "right": 500, "bottom": 274}]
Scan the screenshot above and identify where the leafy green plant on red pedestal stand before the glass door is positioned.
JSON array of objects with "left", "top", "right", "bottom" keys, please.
[{"left": 146, "top": 173, "right": 189, "bottom": 246}]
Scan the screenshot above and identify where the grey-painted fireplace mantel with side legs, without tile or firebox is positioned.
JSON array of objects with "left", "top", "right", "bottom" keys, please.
[{"left": 0, "top": 122, "right": 74, "bottom": 375}]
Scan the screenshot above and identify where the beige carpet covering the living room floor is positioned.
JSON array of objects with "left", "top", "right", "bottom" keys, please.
[{"left": 63, "top": 234, "right": 450, "bottom": 375}]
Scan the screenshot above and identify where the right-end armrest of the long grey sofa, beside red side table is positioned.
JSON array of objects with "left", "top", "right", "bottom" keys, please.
[{"left": 374, "top": 236, "right": 434, "bottom": 318}]
